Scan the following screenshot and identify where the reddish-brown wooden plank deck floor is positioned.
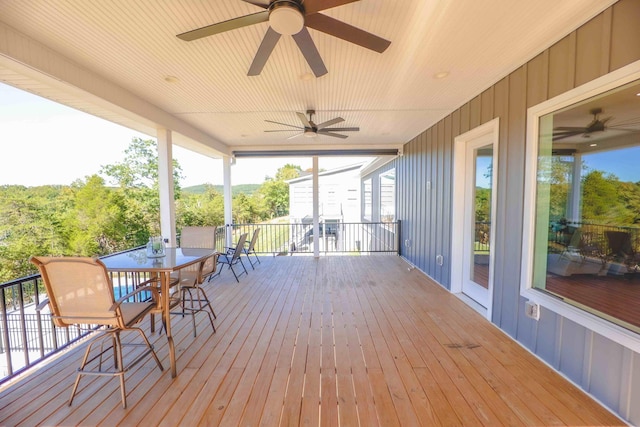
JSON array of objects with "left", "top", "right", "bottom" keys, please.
[{"left": 0, "top": 256, "right": 624, "bottom": 427}]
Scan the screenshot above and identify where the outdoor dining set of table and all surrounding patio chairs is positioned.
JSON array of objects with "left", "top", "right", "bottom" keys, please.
[{"left": 31, "top": 226, "right": 260, "bottom": 408}]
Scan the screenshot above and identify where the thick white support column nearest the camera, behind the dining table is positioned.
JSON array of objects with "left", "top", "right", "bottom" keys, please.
[{"left": 158, "top": 128, "right": 176, "bottom": 246}]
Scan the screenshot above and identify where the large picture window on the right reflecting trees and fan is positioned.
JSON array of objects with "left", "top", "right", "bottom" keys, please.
[{"left": 523, "top": 66, "right": 640, "bottom": 348}]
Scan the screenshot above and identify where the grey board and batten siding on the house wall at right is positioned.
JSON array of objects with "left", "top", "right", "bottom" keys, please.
[{"left": 395, "top": 0, "right": 640, "bottom": 425}]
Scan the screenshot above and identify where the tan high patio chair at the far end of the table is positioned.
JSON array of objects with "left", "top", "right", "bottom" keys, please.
[{"left": 178, "top": 226, "right": 218, "bottom": 337}]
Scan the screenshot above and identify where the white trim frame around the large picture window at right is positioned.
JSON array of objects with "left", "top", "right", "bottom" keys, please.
[{"left": 520, "top": 61, "right": 640, "bottom": 353}]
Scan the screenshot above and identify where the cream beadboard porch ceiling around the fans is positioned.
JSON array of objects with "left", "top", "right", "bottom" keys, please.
[{"left": 0, "top": 0, "right": 615, "bottom": 157}]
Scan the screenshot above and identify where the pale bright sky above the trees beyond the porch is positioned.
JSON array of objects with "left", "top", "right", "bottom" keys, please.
[{"left": 0, "top": 83, "right": 366, "bottom": 188}]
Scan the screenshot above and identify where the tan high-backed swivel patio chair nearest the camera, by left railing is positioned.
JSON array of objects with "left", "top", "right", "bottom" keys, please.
[{"left": 30, "top": 257, "right": 163, "bottom": 408}]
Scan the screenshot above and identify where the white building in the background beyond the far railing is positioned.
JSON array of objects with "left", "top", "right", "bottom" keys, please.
[{"left": 287, "top": 162, "right": 366, "bottom": 229}]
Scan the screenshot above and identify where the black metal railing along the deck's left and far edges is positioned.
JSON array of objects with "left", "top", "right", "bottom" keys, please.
[{"left": 0, "top": 222, "right": 400, "bottom": 384}]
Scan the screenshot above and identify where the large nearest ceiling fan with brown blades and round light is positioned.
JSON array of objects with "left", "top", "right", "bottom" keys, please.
[{"left": 177, "top": 0, "right": 391, "bottom": 77}]
